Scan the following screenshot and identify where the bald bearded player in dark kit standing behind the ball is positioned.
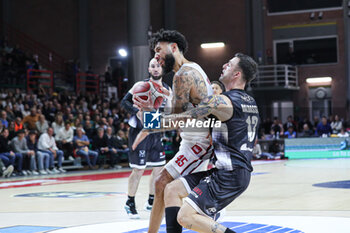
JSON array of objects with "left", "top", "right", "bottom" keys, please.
[{"left": 121, "top": 58, "right": 172, "bottom": 219}]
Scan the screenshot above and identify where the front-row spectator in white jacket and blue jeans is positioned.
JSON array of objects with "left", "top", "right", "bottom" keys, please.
[{"left": 38, "top": 127, "right": 66, "bottom": 173}]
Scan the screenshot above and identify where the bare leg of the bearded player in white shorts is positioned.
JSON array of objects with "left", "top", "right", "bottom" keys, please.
[{"left": 148, "top": 169, "right": 174, "bottom": 233}]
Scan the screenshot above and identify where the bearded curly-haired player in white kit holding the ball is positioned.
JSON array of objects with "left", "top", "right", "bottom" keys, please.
[{"left": 134, "top": 30, "right": 213, "bottom": 233}]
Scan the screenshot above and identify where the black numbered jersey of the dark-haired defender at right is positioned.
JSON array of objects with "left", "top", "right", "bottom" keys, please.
[{"left": 212, "top": 89, "right": 260, "bottom": 171}]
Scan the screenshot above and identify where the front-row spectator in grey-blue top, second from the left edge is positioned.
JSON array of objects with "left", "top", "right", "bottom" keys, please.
[{"left": 11, "top": 130, "right": 39, "bottom": 175}]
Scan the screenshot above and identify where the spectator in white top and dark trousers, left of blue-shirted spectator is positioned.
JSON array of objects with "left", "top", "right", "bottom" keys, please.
[{"left": 55, "top": 121, "right": 74, "bottom": 160}]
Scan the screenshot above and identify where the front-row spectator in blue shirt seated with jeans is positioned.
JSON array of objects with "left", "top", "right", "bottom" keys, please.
[{"left": 73, "top": 127, "right": 98, "bottom": 169}]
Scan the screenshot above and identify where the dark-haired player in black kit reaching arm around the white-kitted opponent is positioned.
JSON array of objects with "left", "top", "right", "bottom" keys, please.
[{"left": 160, "top": 53, "right": 260, "bottom": 233}]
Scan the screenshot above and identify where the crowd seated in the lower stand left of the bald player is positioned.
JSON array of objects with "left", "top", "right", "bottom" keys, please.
[{"left": 0, "top": 89, "right": 129, "bottom": 175}]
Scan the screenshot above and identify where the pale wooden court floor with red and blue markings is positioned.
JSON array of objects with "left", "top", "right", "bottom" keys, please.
[{"left": 0, "top": 159, "right": 350, "bottom": 233}]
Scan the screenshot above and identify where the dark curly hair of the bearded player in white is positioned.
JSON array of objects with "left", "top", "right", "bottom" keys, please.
[{"left": 150, "top": 29, "right": 188, "bottom": 54}]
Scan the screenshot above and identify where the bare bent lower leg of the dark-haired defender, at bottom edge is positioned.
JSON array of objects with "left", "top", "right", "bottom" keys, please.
[{"left": 177, "top": 202, "right": 234, "bottom": 233}]
